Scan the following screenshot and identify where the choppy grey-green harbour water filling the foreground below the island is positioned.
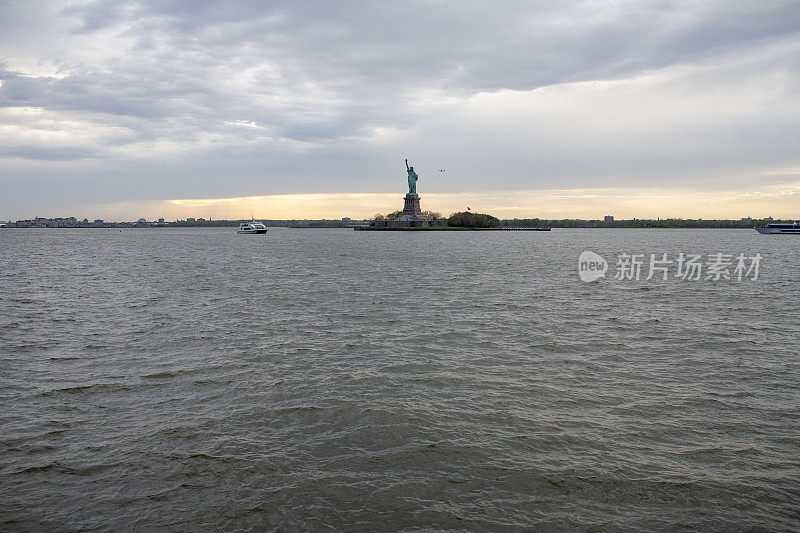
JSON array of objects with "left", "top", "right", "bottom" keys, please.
[{"left": 0, "top": 229, "right": 800, "bottom": 531}]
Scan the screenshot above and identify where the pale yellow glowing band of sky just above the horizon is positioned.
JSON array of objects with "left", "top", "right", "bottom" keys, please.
[{"left": 76, "top": 182, "right": 800, "bottom": 220}]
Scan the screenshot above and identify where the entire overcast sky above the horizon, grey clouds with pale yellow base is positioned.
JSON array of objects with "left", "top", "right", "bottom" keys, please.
[{"left": 0, "top": 0, "right": 800, "bottom": 220}]
